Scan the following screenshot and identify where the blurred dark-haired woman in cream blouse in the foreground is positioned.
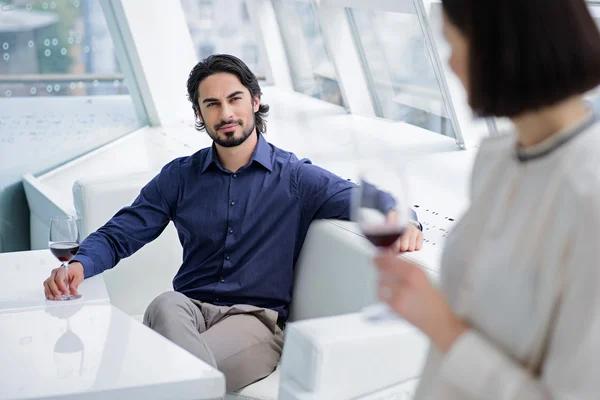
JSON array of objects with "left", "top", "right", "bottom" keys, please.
[{"left": 376, "top": 0, "right": 600, "bottom": 400}]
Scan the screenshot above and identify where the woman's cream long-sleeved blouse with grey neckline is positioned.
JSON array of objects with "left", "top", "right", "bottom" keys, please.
[{"left": 415, "top": 117, "right": 600, "bottom": 400}]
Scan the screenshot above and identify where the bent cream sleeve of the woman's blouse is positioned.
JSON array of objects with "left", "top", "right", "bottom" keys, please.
[{"left": 440, "top": 173, "right": 600, "bottom": 400}]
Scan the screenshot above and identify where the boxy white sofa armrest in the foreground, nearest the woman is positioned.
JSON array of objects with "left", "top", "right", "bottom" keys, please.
[{"left": 279, "top": 313, "right": 429, "bottom": 400}]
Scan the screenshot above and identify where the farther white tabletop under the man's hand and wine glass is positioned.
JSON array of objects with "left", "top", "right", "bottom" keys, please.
[{"left": 0, "top": 250, "right": 110, "bottom": 312}]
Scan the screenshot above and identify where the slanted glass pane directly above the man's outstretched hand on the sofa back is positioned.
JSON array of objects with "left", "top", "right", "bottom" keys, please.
[{"left": 348, "top": 8, "right": 455, "bottom": 137}]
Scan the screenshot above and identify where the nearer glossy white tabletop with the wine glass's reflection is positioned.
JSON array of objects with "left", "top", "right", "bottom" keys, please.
[{"left": 0, "top": 303, "right": 225, "bottom": 400}]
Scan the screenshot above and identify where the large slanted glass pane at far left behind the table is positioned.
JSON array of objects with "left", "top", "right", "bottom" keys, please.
[{"left": 0, "top": 0, "right": 145, "bottom": 251}]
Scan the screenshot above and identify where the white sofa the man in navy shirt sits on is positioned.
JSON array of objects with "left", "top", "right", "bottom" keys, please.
[{"left": 73, "top": 173, "right": 427, "bottom": 400}]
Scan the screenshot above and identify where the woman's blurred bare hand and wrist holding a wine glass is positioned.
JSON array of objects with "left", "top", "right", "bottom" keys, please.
[{"left": 375, "top": 252, "right": 469, "bottom": 353}]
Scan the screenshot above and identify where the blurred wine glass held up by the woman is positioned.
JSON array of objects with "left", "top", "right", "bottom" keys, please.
[{"left": 352, "top": 158, "right": 411, "bottom": 321}]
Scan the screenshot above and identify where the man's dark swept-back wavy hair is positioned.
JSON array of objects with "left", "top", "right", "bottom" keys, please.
[{"left": 187, "top": 54, "right": 269, "bottom": 133}]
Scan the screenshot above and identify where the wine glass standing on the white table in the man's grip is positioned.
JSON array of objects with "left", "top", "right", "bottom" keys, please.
[{"left": 48, "top": 216, "right": 81, "bottom": 300}]
